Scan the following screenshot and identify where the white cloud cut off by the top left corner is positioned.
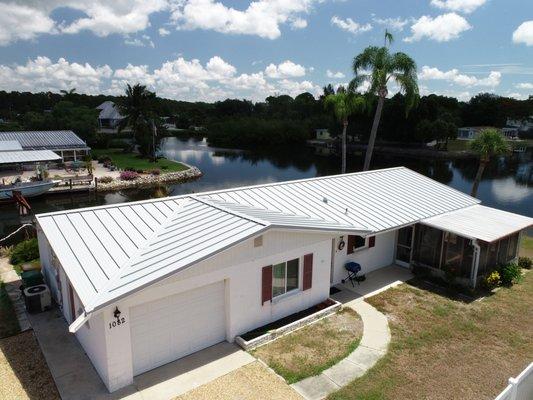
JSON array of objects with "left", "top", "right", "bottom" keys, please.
[{"left": 0, "top": 3, "right": 55, "bottom": 46}]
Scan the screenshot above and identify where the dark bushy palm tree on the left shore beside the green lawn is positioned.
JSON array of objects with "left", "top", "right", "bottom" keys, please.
[{"left": 118, "top": 83, "right": 156, "bottom": 161}]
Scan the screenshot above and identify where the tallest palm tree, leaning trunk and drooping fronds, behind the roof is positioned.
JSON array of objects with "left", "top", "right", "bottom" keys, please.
[{"left": 350, "top": 31, "right": 418, "bottom": 171}]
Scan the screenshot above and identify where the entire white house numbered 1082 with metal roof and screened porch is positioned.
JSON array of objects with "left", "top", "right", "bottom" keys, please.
[{"left": 37, "top": 167, "right": 533, "bottom": 391}]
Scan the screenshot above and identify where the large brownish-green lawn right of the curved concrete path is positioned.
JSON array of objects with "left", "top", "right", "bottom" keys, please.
[{"left": 329, "top": 272, "right": 533, "bottom": 400}]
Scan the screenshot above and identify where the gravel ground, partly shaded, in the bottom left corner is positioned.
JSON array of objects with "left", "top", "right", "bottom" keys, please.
[{"left": 0, "top": 331, "right": 59, "bottom": 400}]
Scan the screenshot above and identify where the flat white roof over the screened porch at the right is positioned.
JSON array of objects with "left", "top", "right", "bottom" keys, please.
[{"left": 422, "top": 205, "right": 533, "bottom": 242}]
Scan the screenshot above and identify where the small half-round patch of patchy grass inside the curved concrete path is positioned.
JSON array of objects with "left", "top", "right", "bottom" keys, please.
[{"left": 252, "top": 308, "right": 363, "bottom": 383}]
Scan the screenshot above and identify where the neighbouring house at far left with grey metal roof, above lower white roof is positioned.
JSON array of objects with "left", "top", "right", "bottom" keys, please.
[{"left": 0, "top": 131, "right": 91, "bottom": 161}]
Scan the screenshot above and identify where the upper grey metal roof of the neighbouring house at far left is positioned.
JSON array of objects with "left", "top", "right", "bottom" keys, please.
[{"left": 0, "top": 131, "right": 88, "bottom": 150}]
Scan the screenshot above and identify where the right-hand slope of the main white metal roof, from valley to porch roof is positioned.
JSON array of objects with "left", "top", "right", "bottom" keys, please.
[{"left": 198, "top": 167, "right": 479, "bottom": 232}]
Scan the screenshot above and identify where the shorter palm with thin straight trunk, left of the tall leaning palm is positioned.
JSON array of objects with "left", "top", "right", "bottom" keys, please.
[{"left": 324, "top": 86, "right": 366, "bottom": 174}]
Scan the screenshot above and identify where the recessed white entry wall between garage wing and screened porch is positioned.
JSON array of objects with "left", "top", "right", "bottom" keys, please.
[{"left": 333, "top": 231, "right": 397, "bottom": 284}]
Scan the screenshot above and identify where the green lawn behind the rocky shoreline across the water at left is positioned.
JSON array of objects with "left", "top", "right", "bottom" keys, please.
[{"left": 91, "top": 149, "right": 188, "bottom": 173}]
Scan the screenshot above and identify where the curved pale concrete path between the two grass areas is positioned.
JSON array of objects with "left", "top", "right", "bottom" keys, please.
[{"left": 291, "top": 298, "right": 390, "bottom": 400}]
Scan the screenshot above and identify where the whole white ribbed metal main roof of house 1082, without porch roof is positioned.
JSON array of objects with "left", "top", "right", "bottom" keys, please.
[{"left": 37, "top": 167, "right": 479, "bottom": 312}]
